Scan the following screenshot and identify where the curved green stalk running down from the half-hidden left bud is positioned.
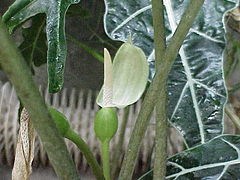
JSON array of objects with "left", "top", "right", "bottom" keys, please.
[{"left": 65, "top": 130, "right": 104, "bottom": 180}]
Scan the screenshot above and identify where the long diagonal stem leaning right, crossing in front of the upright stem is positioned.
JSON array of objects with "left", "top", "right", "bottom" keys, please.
[{"left": 119, "top": 0, "right": 204, "bottom": 180}]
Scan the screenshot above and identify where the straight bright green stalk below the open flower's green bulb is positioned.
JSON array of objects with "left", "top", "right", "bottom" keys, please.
[{"left": 101, "top": 141, "right": 111, "bottom": 180}]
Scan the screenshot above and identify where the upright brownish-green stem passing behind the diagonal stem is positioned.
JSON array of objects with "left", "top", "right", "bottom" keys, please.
[{"left": 152, "top": 0, "right": 167, "bottom": 180}]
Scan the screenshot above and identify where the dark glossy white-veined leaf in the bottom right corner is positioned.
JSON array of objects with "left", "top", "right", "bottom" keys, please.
[{"left": 138, "top": 135, "right": 240, "bottom": 180}]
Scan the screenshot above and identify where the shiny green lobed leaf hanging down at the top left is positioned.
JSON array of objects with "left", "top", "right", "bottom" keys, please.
[{"left": 3, "top": 0, "right": 80, "bottom": 93}]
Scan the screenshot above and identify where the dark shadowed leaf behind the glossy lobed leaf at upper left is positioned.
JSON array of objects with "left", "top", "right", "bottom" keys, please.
[{"left": 19, "top": 14, "right": 47, "bottom": 67}]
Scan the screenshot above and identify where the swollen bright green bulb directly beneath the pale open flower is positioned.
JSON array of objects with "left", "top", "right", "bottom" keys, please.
[{"left": 94, "top": 107, "right": 118, "bottom": 143}]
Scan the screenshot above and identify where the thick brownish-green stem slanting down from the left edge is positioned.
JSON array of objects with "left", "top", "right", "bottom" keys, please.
[{"left": 0, "top": 19, "right": 79, "bottom": 180}]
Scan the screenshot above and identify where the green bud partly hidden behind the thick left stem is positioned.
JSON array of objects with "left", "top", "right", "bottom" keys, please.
[{"left": 48, "top": 106, "right": 70, "bottom": 137}]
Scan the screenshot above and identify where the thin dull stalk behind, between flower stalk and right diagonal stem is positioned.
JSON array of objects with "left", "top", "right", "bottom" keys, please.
[{"left": 112, "top": 106, "right": 129, "bottom": 179}]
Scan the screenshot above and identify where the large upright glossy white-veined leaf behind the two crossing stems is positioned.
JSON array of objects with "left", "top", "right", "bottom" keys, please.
[{"left": 105, "top": 0, "right": 237, "bottom": 147}]
